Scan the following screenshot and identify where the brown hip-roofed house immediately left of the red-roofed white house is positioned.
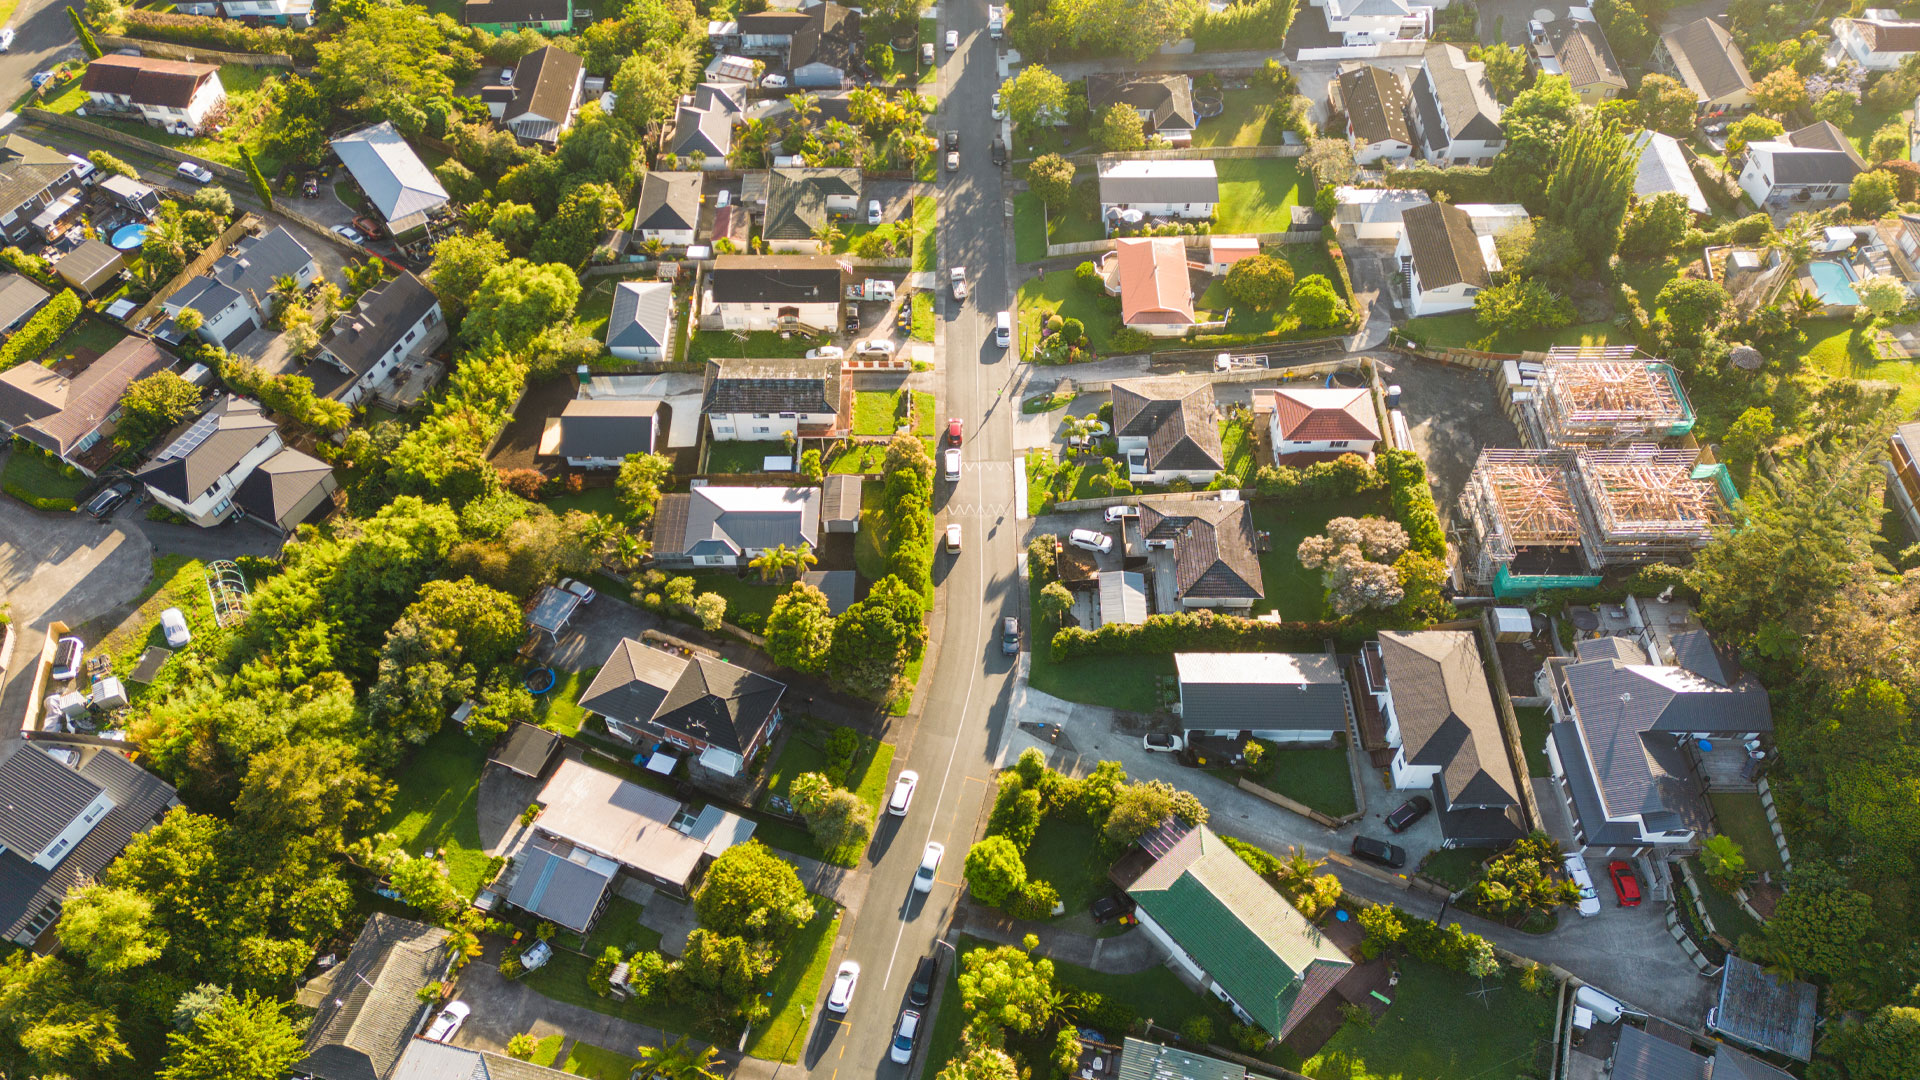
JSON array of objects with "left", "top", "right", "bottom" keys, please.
[{"left": 1114, "top": 376, "right": 1227, "bottom": 486}]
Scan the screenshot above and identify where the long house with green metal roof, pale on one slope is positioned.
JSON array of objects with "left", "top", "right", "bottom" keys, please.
[{"left": 1112, "top": 819, "right": 1354, "bottom": 1053}]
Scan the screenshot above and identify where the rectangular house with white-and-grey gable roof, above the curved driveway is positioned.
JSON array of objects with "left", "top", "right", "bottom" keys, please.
[{"left": 1173, "top": 653, "right": 1348, "bottom": 742}]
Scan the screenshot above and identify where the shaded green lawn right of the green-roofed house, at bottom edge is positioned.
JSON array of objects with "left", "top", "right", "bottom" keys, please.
[{"left": 1297, "top": 959, "right": 1553, "bottom": 1080}]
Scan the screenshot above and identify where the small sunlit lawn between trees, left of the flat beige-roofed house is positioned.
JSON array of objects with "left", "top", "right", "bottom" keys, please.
[{"left": 380, "top": 728, "right": 499, "bottom": 895}]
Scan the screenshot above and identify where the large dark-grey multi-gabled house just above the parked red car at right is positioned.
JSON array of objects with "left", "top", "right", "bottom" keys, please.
[{"left": 1538, "top": 630, "right": 1774, "bottom": 857}]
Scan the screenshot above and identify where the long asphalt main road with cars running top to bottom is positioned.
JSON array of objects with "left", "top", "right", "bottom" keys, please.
[{"left": 801, "top": 0, "right": 1023, "bottom": 1080}]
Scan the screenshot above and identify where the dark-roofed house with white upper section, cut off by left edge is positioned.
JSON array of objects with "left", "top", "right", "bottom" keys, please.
[{"left": 0, "top": 738, "right": 180, "bottom": 953}]
